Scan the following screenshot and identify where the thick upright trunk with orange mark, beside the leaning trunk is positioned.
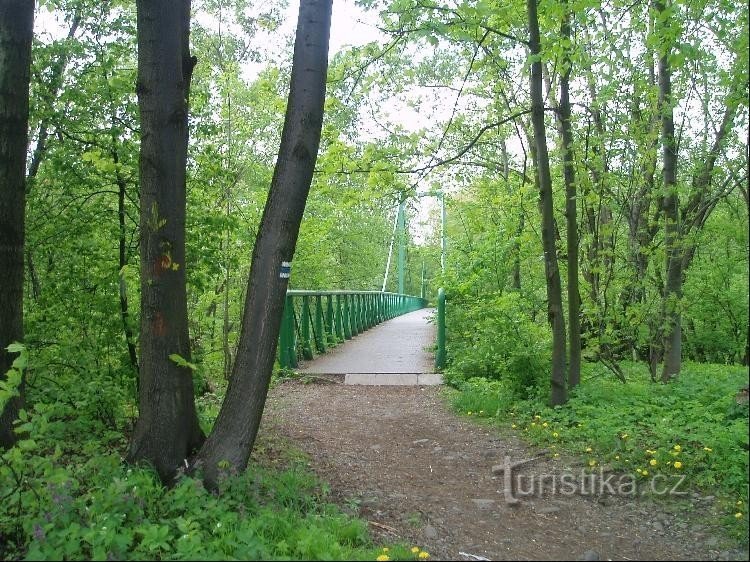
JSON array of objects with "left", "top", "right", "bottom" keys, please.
[{"left": 128, "top": 0, "right": 203, "bottom": 481}]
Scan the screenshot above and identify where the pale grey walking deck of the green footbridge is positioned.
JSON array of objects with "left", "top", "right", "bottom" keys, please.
[{"left": 298, "top": 308, "right": 435, "bottom": 384}]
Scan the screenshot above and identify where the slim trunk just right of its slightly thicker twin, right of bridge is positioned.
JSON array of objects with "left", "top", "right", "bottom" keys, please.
[{"left": 560, "top": 0, "right": 581, "bottom": 388}]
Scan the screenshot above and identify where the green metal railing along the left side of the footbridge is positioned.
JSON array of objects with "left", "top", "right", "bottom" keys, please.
[{"left": 279, "top": 290, "right": 427, "bottom": 369}]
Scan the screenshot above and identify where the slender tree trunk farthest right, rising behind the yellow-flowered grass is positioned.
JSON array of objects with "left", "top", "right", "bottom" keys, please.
[{"left": 654, "top": 0, "right": 682, "bottom": 382}]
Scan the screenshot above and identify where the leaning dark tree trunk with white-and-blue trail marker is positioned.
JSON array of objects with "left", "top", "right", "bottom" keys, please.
[{"left": 195, "top": 0, "right": 331, "bottom": 487}]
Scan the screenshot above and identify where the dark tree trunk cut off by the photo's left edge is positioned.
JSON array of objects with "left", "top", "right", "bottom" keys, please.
[{"left": 0, "top": 0, "right": 34, "bottom": 447}]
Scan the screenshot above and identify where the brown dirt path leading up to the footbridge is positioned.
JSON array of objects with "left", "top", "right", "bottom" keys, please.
[{"left": 262, "top": 382, "right": 747, "bottom": 560}]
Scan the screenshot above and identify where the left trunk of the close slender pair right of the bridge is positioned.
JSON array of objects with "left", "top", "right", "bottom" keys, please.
[{"left": 526, "top": 0, "right": 568, "bottom": 406}]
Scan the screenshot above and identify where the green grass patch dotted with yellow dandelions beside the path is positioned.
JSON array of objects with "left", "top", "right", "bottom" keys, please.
[{"left": 450, "top": 363, "right": 750, "bottom": 542}]
